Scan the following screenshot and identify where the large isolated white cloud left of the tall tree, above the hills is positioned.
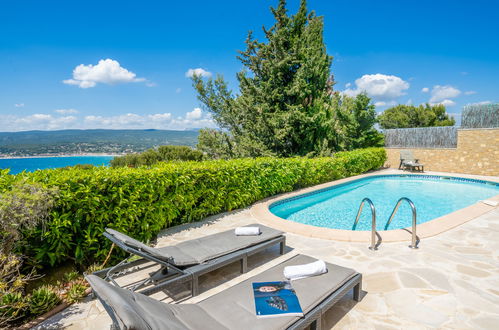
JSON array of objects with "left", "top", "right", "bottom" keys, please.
[{"left": 63, "top": 58, "right": 146, "bottom": 88}]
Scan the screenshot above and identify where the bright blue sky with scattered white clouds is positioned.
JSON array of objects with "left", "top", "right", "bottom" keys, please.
[{"left": 0, "top": 0, "right": 499, "bottom": 131}]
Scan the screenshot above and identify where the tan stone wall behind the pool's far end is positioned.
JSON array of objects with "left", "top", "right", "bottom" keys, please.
[{"left": 386, "top": 128, "right": 499, "bottom": 176}]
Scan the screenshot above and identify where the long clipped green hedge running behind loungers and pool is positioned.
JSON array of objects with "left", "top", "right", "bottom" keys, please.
[{"left": 0, "top": 148, "right": 386, "bottom": 265}]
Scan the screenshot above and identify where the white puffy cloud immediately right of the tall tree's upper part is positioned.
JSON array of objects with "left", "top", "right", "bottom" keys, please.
[{"left": 343, "top": 73, "right": 410, "bottom": 102}]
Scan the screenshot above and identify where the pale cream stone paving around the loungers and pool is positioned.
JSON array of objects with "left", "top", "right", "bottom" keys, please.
[{"left": 37, "top": 173, "right": 499, "bottom": 330}]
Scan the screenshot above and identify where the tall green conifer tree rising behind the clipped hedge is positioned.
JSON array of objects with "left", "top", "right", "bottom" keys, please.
[{"left": 193, "top": 0, "right": 378, "bottom": 157}]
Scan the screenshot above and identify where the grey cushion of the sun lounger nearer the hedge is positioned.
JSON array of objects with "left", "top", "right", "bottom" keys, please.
[{"left": 106, "top": 224, "right": 283, "bottom": 266}]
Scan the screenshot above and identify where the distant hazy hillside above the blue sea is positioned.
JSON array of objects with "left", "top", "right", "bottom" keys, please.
[{"left": 0, "top": 129, "right": 198, "bottom": 156}]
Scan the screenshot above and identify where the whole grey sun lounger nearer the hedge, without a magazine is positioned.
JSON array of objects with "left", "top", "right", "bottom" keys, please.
[{"left": 94, "top": 224, "right": 286, "bottom": 296}]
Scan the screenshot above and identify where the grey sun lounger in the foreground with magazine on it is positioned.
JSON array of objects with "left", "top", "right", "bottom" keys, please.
[{"left": 86, "top": 255, "right": 362, "bottom": 330}]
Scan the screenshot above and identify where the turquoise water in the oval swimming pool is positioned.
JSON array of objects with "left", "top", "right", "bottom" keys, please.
[{"left": 270, "top": 175, "right": 499, "bottom": 231}]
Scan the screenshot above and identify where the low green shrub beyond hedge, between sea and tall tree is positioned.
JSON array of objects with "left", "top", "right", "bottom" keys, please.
[{"left": 111, "top": 146, "right": 203, "bottom": 167}]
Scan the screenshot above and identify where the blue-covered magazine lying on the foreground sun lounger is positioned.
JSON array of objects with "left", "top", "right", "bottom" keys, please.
[{"left": 253, "top": 281, "right": 303, "bottom": 317}]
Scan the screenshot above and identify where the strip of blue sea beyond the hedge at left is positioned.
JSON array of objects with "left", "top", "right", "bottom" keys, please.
[{"left": 0, "top": 156, "right": 114, "bottom": 174}]
